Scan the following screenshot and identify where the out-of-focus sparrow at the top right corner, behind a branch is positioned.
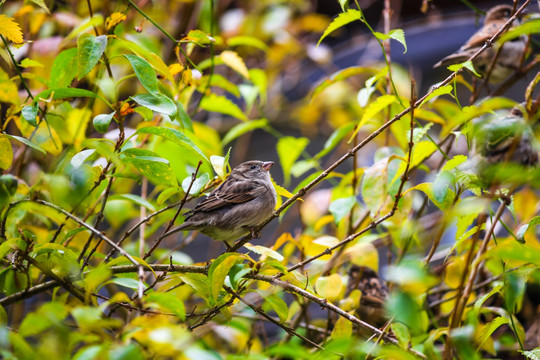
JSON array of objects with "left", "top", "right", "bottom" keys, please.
[{"left": 433, "top": 5, "right": 527, "bottom": 84}]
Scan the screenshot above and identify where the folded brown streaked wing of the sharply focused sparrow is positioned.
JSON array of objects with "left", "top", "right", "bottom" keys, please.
[{"left": 192, "top": 181, "right": 261, "bottom": 213}]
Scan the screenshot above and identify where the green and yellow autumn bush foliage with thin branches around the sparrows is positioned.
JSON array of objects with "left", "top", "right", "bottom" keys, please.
[{"left": 0, "top": 0, "right": 540, "bottom": 360}]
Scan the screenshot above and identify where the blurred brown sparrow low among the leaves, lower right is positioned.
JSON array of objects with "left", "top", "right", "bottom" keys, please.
[{"left": 346, "top": 265, "right": 390, "bottom": 327}]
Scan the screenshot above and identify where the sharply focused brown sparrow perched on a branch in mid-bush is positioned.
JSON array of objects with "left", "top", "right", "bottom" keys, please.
[{"left": 172, "top": 161, "right": 277, "bottom": 245}]
